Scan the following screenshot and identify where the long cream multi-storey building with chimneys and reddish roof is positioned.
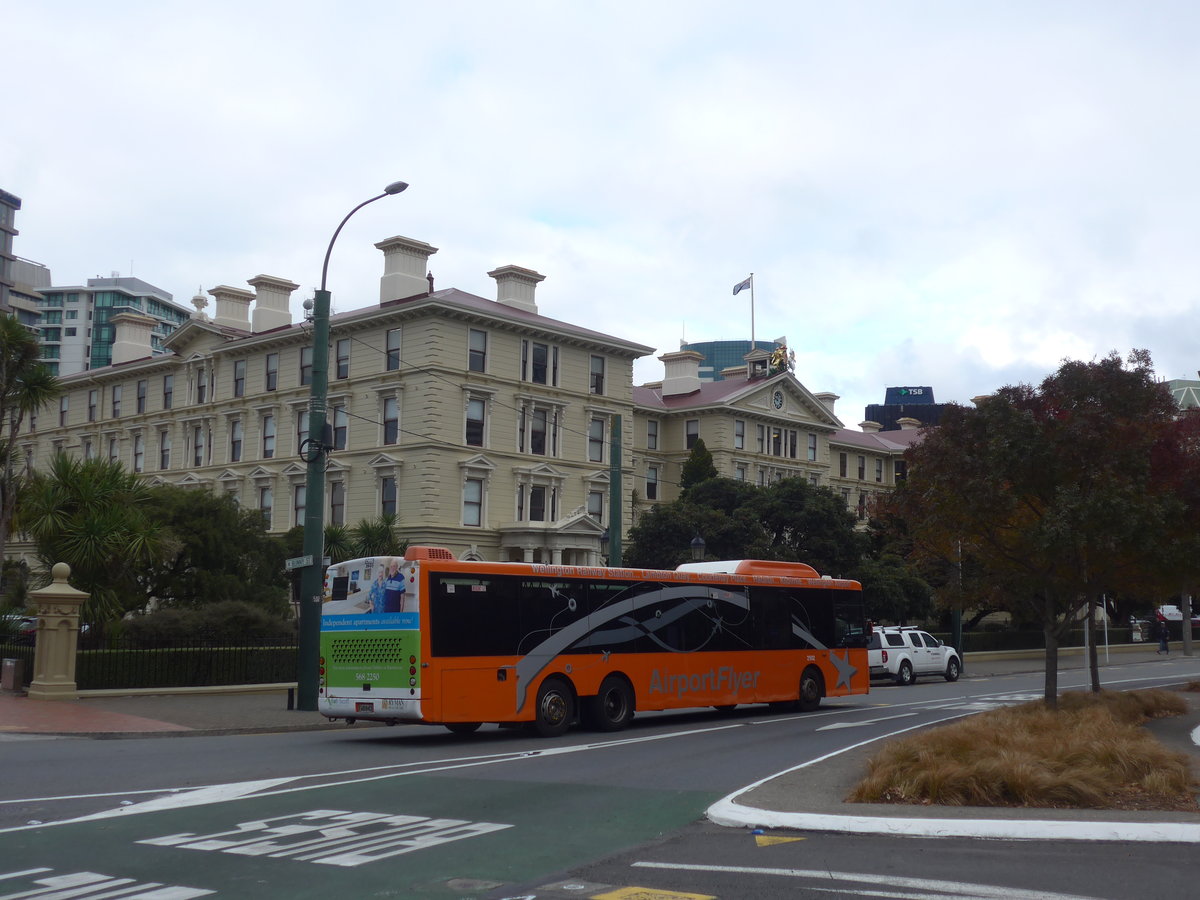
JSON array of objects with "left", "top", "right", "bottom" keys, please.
[{"left": 13, "top": 238, "right": 917, "bottom": 564}]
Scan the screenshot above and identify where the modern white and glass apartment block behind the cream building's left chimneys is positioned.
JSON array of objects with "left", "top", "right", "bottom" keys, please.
[{"left": 38, "top": 275, "right": 190, "bottom": 376}]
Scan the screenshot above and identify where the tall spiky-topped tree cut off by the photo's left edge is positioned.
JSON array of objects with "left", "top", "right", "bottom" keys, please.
[{"left": 0, "top": 316, "right": 60, "bottom": 559}]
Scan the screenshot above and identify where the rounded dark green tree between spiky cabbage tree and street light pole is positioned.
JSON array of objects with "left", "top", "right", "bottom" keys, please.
[{"left": 142, "top": 485, "right": 288, "bottom": 614}]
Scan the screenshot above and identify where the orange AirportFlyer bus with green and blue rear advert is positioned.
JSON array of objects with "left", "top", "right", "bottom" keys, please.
[{"left": 318, "top": 546, "right": 869, "bottom": 737}]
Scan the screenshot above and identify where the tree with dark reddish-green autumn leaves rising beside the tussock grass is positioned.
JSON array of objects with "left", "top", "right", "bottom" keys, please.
[{"left": 892, "top": 350, "right": 1195, "bottom": 706}]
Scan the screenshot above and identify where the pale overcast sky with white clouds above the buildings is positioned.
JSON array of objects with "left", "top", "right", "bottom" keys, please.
[{"left": 0, "top": 0, "right": 1200, "bottom": 427}]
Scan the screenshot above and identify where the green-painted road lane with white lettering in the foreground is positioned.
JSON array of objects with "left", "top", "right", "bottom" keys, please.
[{"left": 0, "top": 775, "right": 719, "bottom": 900}]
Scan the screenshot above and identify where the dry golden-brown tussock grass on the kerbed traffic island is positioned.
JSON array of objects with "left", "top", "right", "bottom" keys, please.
[{"left": 846, "top": 690, "right": 1200, "bottom": 811}]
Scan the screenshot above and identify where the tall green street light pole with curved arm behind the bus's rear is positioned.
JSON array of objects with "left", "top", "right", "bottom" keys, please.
[{"left": 296, "top": 181, "right": 408, "bottom": 712}]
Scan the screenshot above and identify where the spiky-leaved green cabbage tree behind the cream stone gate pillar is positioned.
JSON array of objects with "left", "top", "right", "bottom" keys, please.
[{"left": 13, "top": 454, "right": 168, "bottom": 624}]
